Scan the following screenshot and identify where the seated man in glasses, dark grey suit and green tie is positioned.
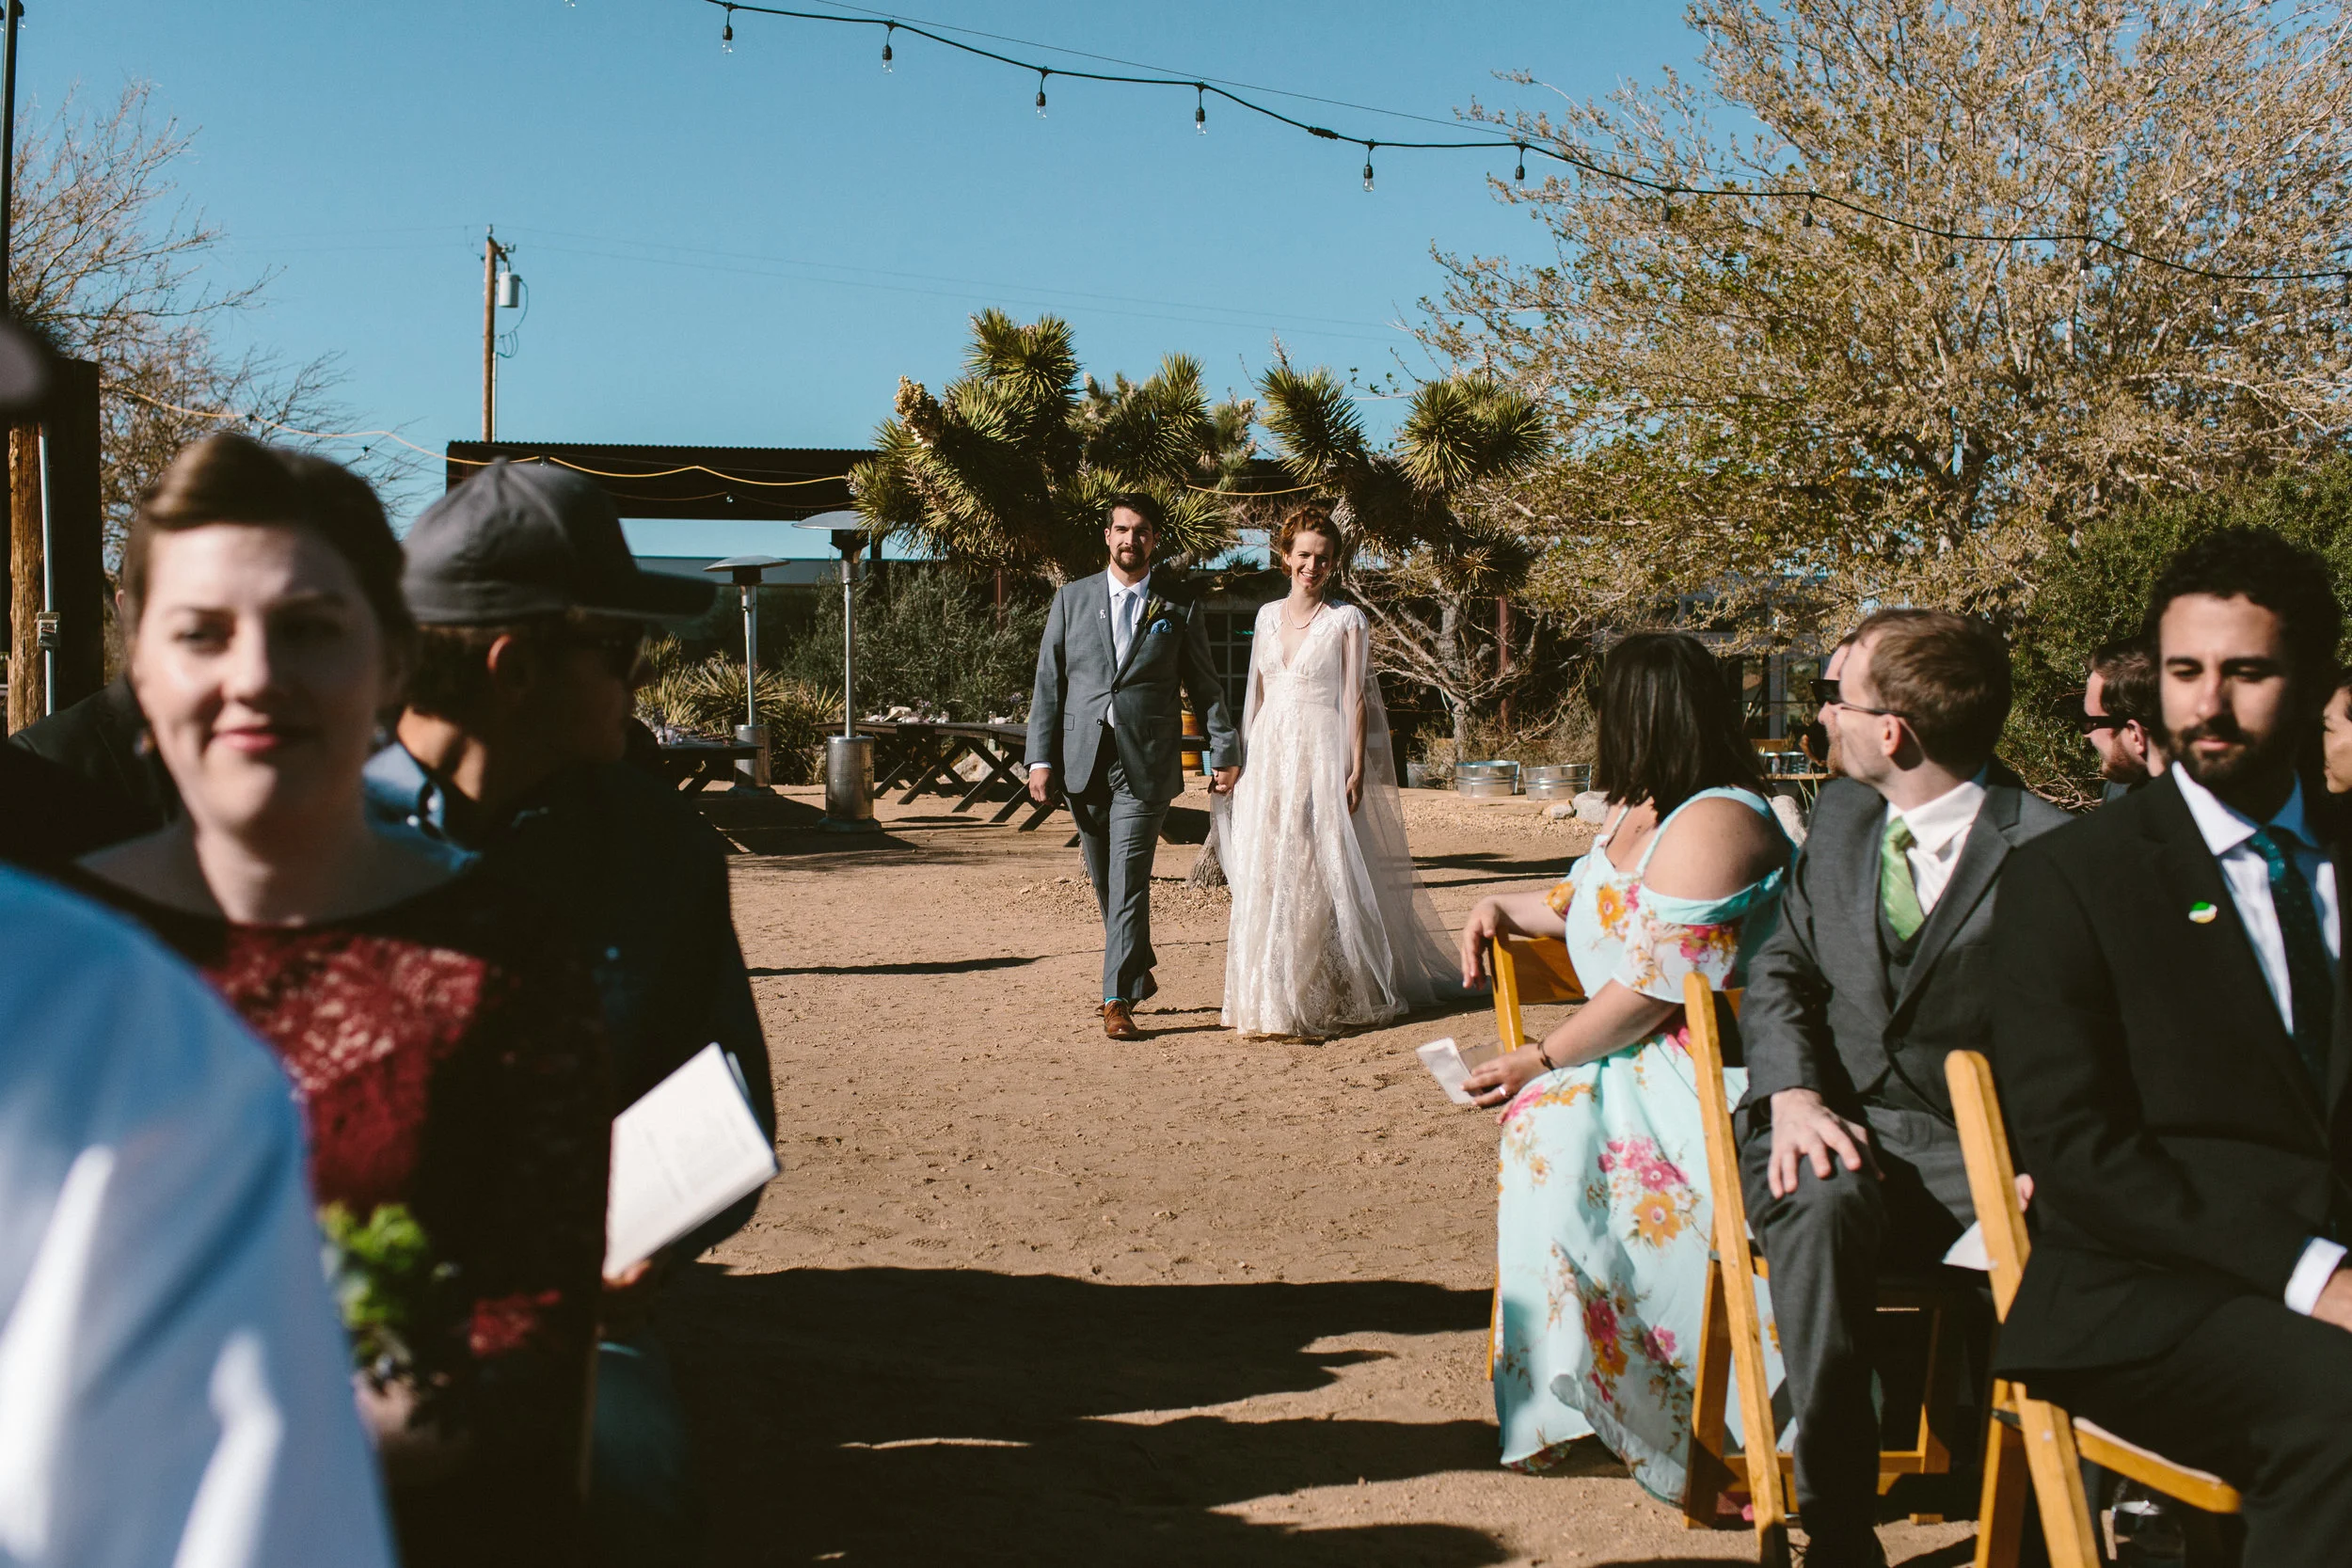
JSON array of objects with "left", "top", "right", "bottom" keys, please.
[{"left": 1736, "top": 609, "right": 2065, "bottom": 1568}]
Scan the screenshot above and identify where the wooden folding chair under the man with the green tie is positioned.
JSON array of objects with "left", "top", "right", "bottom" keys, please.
[{"left": 1682, "top": 975, "right": 1974, "bottom": 1568}]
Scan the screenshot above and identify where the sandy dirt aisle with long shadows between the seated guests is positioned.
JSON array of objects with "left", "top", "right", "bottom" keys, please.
[{"left": 663, "top": 792, "right": 1966, "bottom": 1568}]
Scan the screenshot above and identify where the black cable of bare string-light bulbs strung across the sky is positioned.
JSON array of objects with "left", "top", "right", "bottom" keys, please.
[{"left": 704, "top": 0, "right": 2352, "bottom": 293}]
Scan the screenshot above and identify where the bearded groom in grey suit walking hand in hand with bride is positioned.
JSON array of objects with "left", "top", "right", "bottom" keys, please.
[{"left": 1028, "top": 494, "right": 1242, "bottom": 1039}]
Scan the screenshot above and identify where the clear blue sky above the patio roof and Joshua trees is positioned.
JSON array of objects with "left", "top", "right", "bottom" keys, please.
[{"left": 19, "top": 0, "right": 1692, "bottom": 552}]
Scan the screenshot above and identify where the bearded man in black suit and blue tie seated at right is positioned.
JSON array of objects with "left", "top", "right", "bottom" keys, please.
[{"left": 1990, "top": 527, "right": 2352, "bottom": 1568}]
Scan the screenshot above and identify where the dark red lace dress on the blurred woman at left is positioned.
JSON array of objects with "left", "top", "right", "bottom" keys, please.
[{"left": 97, "top": 875, "right": 612, "bottom": 1568}]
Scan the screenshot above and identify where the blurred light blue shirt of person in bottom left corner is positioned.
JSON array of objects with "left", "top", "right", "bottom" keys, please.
[{"left": 0, "top": 870, "right": 393, "bottom": 1568}]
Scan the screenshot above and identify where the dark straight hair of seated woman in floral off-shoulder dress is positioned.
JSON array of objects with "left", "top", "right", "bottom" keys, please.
[{"left": 1593, "top": 632, "right": 1764, "bottom": 816}]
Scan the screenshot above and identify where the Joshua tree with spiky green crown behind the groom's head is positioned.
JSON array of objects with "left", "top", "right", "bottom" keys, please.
[{"left": 850, "top": 310, "right": 1256, "bottom": 580}]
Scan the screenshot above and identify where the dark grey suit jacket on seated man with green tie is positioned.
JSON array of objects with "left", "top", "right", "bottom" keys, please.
[{"left": 1740, "top": 762, "right": 2068, "bottom": 1135}]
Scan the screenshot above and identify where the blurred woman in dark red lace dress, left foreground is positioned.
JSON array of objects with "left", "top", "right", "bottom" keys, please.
[{"left": 83, "top": 435, "right": 612, "bottom": 1568}]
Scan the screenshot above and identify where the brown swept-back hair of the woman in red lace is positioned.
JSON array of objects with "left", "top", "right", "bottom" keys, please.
[{"left": 122, "top": 435, "right": 417, "bottom": 663}]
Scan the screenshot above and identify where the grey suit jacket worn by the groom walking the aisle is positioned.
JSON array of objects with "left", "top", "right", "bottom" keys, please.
[{"left": 1028, "top": 571, "right": 1242, "bottom": 801}]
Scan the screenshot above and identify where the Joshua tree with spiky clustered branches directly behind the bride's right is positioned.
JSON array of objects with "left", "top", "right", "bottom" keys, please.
[{"left": 1259, "top": 359, "right": 1550, "bottom": 752}]
